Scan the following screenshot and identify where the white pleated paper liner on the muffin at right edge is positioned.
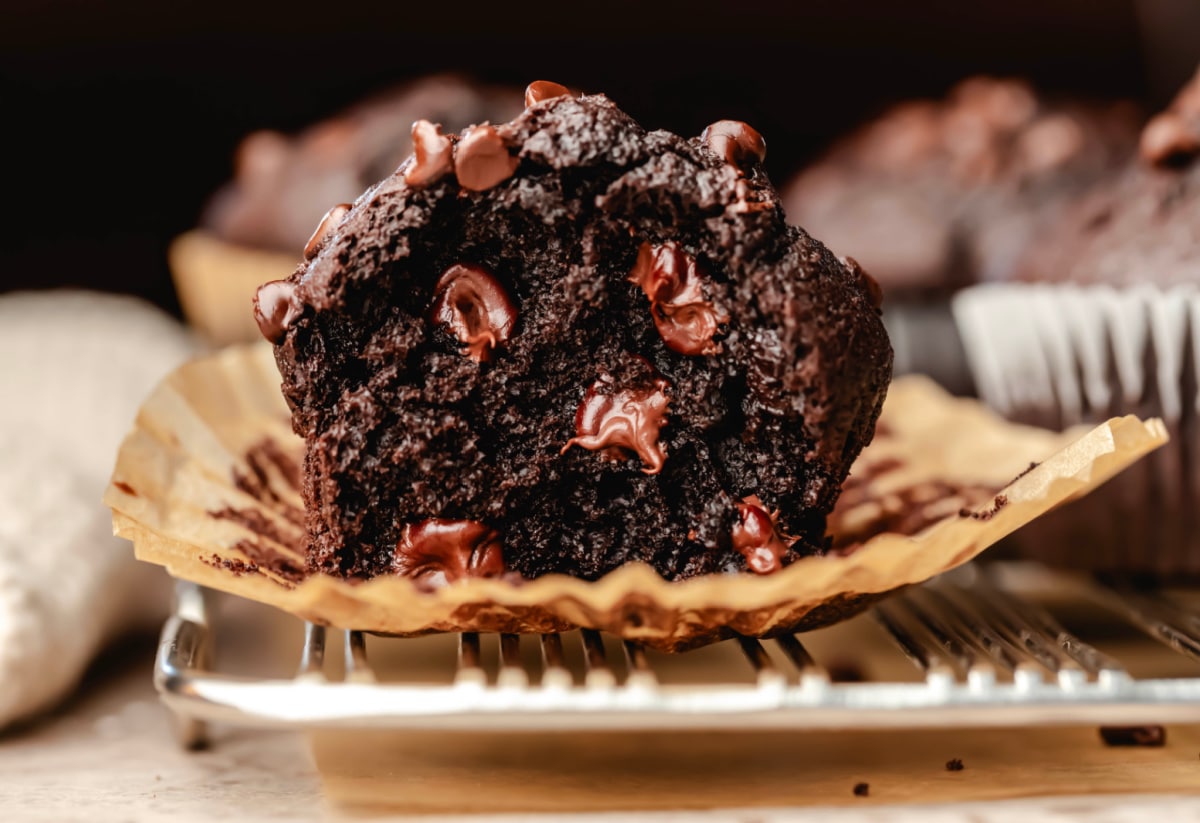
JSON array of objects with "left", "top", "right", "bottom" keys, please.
[{"left": 953, "top": 283, "right": 1200, "bottom": 577}]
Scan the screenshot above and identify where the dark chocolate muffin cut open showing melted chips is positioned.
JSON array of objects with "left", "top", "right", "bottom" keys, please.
[{"left": 256, "top": 83, "right": 892, "bottom": 585}]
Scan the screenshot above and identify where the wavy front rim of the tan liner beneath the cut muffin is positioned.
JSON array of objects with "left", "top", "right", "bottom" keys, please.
[{"left": 104, "top": 415, "right": 1169, "bottom": 631}]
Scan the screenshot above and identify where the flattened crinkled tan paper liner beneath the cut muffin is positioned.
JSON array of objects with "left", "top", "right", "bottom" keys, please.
[{"left": 104, "top": 344, "right": 1166, "bottom": 650}]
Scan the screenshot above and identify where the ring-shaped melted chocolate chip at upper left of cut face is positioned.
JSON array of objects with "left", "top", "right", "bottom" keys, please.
[{"left": 433, "top": 263, "right": 517, "bottom": 362}]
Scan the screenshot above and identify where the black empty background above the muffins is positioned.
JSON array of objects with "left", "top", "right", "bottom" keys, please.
[{"left": 0, "top": 0, "right": 1200, "bottom": 310}]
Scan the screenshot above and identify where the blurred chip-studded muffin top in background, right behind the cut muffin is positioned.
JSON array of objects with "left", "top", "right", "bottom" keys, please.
[{"left": 784, "top": 77, "right": 1138, "bottom": 293}]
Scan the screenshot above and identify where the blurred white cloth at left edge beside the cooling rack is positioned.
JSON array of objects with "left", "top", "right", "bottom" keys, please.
[{"left": 0, "top": 292, "right": 194, "bottom": 727}]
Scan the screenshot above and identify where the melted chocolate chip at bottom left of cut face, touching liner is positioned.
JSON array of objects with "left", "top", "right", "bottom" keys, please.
[{"left": 392, "top": 518, "right": 505, "bottom": 588}]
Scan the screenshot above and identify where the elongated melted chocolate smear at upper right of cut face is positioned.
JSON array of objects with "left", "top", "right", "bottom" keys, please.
[{"left": 629, "top": 241, "right": 730, "bottom": 355}]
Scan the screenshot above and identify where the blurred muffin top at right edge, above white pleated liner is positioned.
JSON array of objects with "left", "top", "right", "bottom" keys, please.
[{"left": 1018, "top": 65, "right": 1200, "bottom": 287}]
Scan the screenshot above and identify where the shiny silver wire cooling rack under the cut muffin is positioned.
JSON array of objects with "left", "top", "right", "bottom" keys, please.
[{"left": 155, "top": 569, "right": 1200, "bottom": 746}]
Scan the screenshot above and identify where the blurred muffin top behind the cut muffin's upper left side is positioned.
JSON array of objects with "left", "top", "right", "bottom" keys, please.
[{"left": 200, "top": 74, "right": 521, "bottom": 256}]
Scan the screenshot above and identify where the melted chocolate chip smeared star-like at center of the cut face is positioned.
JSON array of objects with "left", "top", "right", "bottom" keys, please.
[{"left": 560, "top": 378, "right": 671, "bottom": 474}]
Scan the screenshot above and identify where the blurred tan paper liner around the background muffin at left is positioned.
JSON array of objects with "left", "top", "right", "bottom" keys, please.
[{"left": 168, "top": 229, "right": 300, "bottom": 346}]
